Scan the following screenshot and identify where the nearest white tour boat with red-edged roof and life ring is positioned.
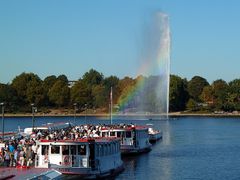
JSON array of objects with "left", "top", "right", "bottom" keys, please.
[{"left": 35, "top": 137, "right": 123, "bottom": 179}]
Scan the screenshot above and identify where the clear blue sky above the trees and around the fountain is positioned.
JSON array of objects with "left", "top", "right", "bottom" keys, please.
[{"left": 0, "top": 0, "right": 240, "bottom": 83}]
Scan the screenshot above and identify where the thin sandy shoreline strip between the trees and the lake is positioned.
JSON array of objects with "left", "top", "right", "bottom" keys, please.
[{"left": 4, "top": 112, "right": 240, "bottom": 117}]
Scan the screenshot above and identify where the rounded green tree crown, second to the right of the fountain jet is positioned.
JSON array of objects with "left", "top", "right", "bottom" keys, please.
[{"left": 188, "top": 76, "right": 209, "bottom": 102}]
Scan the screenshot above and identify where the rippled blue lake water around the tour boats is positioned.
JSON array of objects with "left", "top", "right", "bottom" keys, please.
[{"left": 1, "top": 117, "right": 240, "bottom": 180}]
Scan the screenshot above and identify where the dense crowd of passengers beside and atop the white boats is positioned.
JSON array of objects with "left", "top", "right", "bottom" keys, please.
[{"left": 0, "top": 124, "right": 134, "bottom": 167}]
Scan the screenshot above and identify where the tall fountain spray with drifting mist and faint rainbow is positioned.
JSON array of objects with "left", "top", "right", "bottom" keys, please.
[{"left": 124, "top": 12, "right": 171, "bottom": 116}]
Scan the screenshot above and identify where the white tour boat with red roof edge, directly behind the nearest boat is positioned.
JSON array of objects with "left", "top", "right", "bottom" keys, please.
[{"left": 100, "top": 124, "right": 151, "bottom": 154}]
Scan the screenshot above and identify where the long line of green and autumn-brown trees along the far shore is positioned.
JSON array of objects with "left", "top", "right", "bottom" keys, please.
[{"left": 0, "top": 69, "right": 240, "bottom": 113}]
